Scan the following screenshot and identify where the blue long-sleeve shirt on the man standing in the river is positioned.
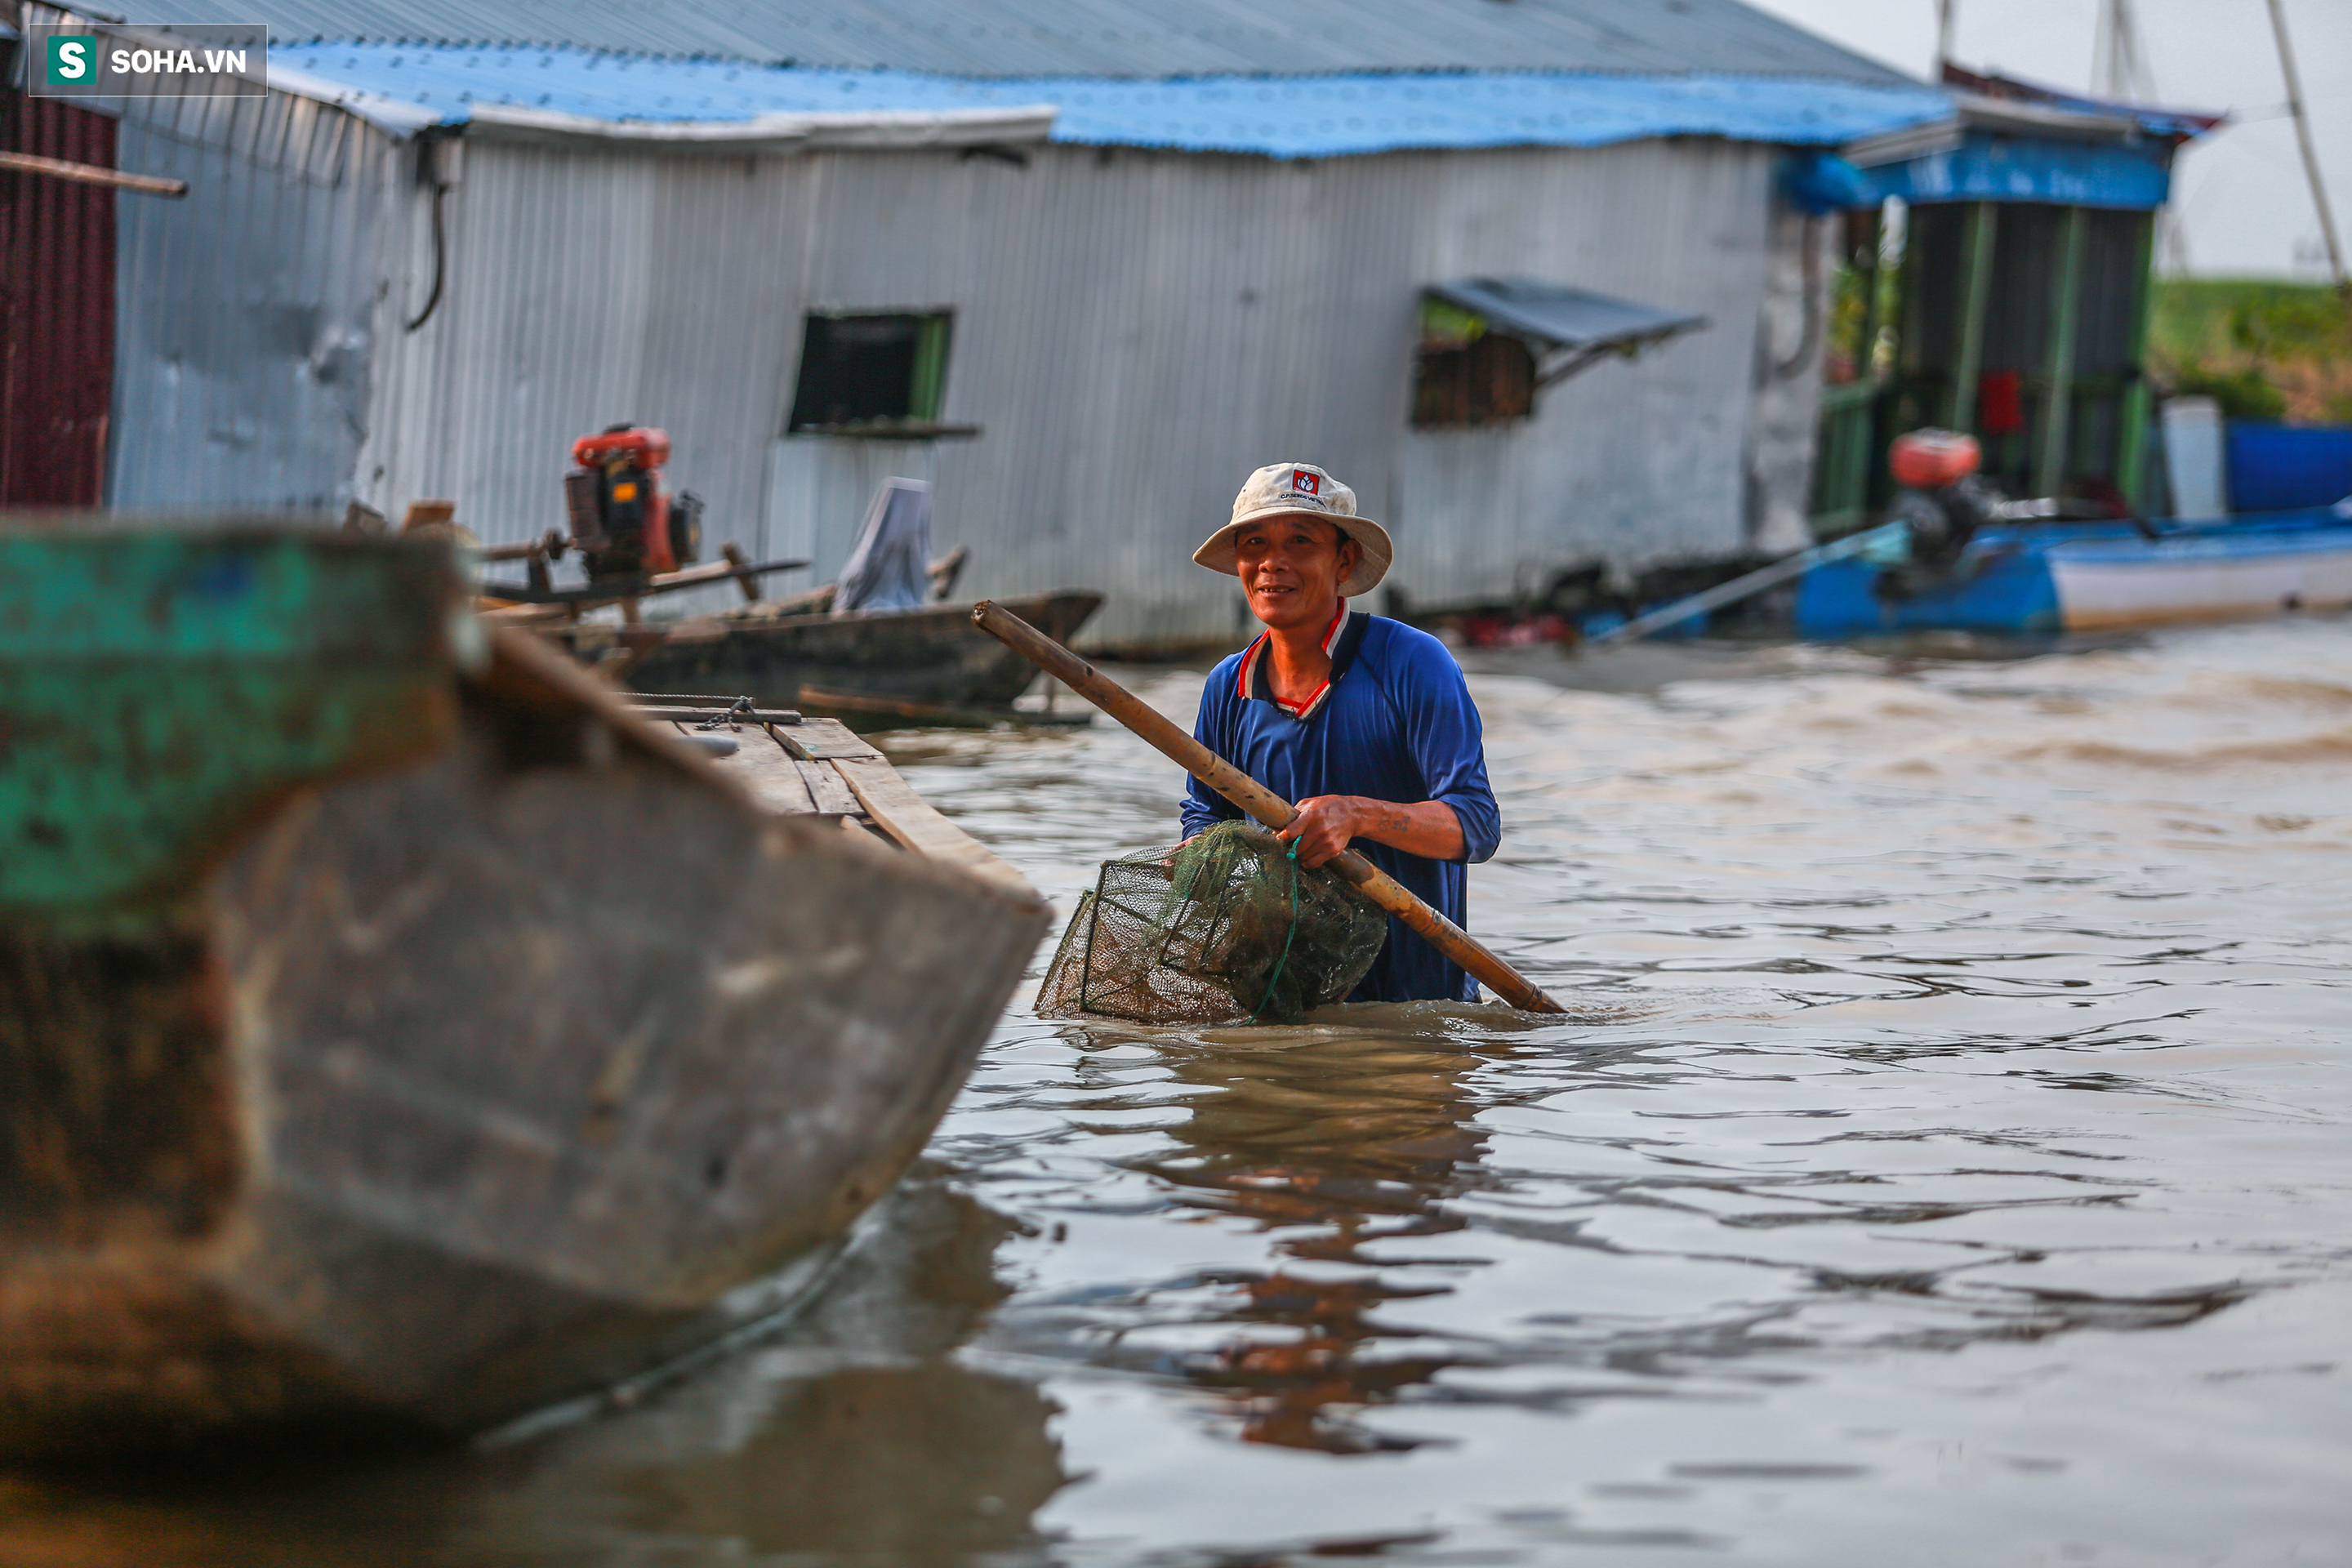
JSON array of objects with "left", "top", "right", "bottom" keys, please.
[{"left": 1183, "top": 609, "right": 1503, "bottom": 1001}]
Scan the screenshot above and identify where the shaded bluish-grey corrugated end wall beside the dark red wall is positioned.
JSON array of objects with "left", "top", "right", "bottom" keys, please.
[{"left": 106, "top": 91, "right": 397, "bottom": 510}]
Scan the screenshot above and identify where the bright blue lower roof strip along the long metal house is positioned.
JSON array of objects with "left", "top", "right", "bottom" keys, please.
[{"left": 270, "top": 42, "right": 1952, "bottom": 158}]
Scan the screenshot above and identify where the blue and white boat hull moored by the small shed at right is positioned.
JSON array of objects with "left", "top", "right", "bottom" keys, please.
[{"left": 1797, "top": 508, "right": 2352, "bottom": 637}]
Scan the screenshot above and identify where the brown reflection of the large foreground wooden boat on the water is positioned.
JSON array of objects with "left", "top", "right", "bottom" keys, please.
[{"left": 0, "top": 1166, "right": 1068, "bottom": 1568}]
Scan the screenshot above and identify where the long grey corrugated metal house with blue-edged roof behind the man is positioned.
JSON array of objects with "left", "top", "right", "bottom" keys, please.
[{"left": 0, "top": 0, "right": 1952, "bottom": 648}]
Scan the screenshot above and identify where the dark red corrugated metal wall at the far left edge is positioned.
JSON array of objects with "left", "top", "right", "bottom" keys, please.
[{"left": 0, "top": 89, "right": 115, "bottom": 506}]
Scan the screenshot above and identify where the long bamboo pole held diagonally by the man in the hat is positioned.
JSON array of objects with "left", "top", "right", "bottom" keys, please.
[{"left": 971, "top": 599, "right": 1566, "bottom": 1013}]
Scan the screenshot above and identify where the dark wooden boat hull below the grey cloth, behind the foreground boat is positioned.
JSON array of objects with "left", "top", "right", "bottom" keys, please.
[{"left": 555, "top": 592, "right": 1103, "bottom": 712}]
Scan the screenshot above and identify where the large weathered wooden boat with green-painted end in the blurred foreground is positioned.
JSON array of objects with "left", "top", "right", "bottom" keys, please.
[{"left": 0, "top": 529, "right": 1049, "bottom": 1458}]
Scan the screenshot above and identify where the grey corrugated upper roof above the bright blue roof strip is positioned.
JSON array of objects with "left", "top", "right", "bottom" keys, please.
[{"left": 151, "top": 0, "right": 1908, "bottom": 82}]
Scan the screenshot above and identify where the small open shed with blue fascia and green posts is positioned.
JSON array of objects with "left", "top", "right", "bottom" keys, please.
[{"left": 1813, "top": 66, "right": 2221, "bottom": 533}]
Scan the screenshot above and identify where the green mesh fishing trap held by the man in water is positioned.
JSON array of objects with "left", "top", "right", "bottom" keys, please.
[{"left": 1037, "top": 822, "right": 1388, "bottom": 1022}]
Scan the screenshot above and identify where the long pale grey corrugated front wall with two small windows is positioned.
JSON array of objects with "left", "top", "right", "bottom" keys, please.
[{"left": 372, "top": 141, "right": 1809, "bottom": 644}]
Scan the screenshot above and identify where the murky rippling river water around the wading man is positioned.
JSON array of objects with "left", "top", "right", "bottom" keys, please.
[{"left": 0, "top": 621, "right": 2352, "bottom": 1568}]
